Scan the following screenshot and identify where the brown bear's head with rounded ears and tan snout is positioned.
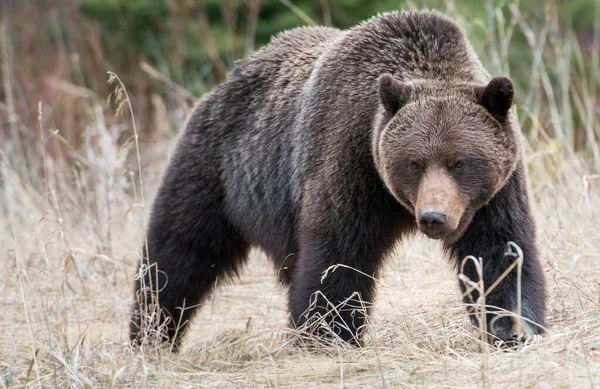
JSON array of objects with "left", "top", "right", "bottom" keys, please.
[{"left": 373, "top": 74, "right": 520, "bottom": 242}]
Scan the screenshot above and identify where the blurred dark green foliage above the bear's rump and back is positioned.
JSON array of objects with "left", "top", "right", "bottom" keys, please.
[{"left": 80, "top": 0, "right": 441, "bottom": 93}]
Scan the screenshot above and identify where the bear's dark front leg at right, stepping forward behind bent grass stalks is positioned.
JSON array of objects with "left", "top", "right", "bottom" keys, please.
[{"left": 446, "top": 163, "right": 546, "bottom": 342}]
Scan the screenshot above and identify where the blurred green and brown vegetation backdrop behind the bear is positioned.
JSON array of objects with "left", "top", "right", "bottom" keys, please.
[{"left": 0, "top": 0, "right": 600, "bottom": 186}]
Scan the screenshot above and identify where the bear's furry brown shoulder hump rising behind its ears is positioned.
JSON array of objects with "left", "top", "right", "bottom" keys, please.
[{"left": 328, "top": 11, "right": 489, "bottom": 87}]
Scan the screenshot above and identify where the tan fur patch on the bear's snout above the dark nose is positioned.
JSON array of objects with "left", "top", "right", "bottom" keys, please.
[{"left": 415, "top": 169, "right": 464, "bottom": 234}]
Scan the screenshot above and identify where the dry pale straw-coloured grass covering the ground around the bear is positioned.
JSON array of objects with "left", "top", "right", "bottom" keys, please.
[{"left": 0, "top": 0, "right": 600, "bottom": 388}]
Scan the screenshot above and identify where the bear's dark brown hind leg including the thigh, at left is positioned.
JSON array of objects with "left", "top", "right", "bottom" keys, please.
[{"left": 130, "top": 146, "right": 249, "bottom": 347}]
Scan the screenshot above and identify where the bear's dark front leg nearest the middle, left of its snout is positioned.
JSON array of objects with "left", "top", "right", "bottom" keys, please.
[{"left": 289, "top": 185, "right": 414, "bottom": 345}]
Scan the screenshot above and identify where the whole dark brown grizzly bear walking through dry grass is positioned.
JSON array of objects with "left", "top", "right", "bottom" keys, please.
[{"left": 131, "top": 11, "right": 545, "bottom": 347}]
